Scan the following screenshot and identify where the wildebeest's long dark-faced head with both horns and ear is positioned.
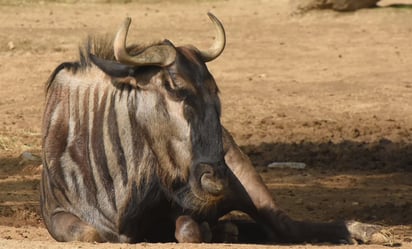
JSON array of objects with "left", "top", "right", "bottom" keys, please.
[{"left": 90, "top": 13, "right": 227, "bottom": 211}]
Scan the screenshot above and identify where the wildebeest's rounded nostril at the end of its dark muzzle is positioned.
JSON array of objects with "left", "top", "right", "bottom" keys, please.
[{"left": 200, "top": 164, "right": 227, "bottom": 195}]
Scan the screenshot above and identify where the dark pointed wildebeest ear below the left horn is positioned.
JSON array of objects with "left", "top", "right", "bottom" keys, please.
[{"left": 89, "top": 54, "right": 134, "bottom": 78}]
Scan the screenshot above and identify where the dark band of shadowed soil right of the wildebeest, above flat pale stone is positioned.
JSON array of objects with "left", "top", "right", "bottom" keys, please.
[{"left": 241, "top": 139, "right": 412, "bottom": 172}]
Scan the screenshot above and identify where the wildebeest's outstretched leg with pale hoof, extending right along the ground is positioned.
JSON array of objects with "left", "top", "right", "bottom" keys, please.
[{"left": 223, "top": 129, "right": 385, "bottom": 243}]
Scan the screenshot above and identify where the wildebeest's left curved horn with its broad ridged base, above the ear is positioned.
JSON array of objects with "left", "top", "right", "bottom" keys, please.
[{"left": 113, "top": 17, "right": 176, "bottom": 66}]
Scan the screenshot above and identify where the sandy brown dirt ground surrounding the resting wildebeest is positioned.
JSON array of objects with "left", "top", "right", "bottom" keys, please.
[{"left": 0, "top": 0, "right": 412, "bottom": 249}]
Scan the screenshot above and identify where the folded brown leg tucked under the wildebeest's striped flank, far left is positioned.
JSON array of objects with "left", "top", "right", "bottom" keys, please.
[{"left": 49, "top": 212, "right": 104, "bottom": 242}]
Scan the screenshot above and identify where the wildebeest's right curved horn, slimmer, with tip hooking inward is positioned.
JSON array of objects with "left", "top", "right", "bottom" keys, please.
[{"left": 200, "top": 12, "right": 226, "bottom": 62}]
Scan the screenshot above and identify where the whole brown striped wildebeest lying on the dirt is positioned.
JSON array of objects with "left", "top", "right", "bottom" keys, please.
[{"left": 41, "top": 14, "right": 390, "bottom": 243}]
